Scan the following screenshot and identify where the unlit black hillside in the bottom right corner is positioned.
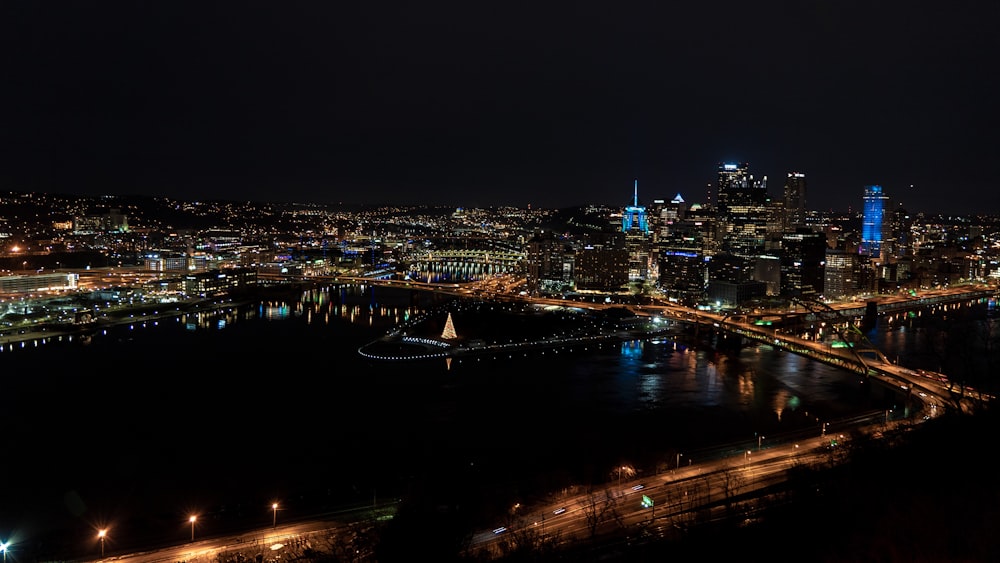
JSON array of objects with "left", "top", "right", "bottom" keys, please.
[{"left": 472, "top": 409, "right": 1000, "bottom": 563}]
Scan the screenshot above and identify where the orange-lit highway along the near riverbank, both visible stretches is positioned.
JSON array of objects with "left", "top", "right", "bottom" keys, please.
[{"left": 86, "top": 413, "right": 896, "bottom": 563}]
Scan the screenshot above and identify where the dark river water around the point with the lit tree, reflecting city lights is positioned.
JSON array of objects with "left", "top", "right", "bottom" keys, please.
[{"left": 0, "top": 286, "right": 980, "bottom": 552}]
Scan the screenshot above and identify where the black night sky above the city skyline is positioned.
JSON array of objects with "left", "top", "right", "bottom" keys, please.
[{"left": 0, "top": 0, "right": 1000, "bottom": 214}]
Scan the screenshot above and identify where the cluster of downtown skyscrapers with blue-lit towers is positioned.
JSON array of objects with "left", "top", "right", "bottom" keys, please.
[{"left": 527, "top": 163, "right": 1000, "bottom": 309}]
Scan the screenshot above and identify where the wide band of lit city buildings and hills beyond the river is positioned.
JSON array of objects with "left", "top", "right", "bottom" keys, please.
[{"left": 0, "top": 174, "right": 1000, "bottom": 308}]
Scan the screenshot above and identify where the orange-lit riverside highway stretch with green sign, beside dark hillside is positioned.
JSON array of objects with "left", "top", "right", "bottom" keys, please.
[{"left": 469, "top": 415, "right": 908, "bottom": 556}]
